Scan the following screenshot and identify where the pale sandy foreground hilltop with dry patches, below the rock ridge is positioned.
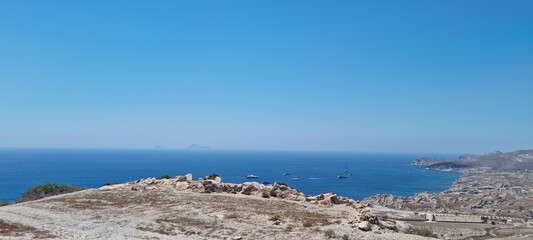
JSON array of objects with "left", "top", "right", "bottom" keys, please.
[{"left": 0, "top": 189, "right": 427, "bottom": 239}]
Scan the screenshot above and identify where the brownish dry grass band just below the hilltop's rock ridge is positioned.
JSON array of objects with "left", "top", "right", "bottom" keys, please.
[{"left": 42, "top": 191, "right": 331, "bottom": 225}]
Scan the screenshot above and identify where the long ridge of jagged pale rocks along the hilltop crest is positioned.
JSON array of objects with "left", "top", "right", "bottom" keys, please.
[{"left": 100, "top": 173, "right": 378, "bottom": 231}]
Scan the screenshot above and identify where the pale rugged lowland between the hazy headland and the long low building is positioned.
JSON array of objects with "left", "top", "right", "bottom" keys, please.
[{"left": 364, "top": 171, "right": 533, "bottom": 220}]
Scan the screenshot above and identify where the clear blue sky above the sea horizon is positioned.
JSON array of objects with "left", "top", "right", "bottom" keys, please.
[{"left": 0, "top": 0, "right": 533, "bottom": 153}]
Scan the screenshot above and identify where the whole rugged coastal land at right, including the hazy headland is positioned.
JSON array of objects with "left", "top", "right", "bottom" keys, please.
[{"left": 363, "top": 150, "right": 533, "bottom": 239}]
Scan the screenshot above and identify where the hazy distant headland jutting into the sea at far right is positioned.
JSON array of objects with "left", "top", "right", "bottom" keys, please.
[{"left": 412, "top": 150, "right": 533, "bottom": 171}]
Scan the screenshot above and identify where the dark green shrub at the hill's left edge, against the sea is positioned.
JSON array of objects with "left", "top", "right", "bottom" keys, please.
[{"left": 17, "top": 183, "right": 84, "bottom": 202}]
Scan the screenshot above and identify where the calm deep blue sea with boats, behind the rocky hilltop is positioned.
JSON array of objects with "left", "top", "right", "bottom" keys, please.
[{"left": 0, "top": 149, "right": 459, "bottom": 202}]
